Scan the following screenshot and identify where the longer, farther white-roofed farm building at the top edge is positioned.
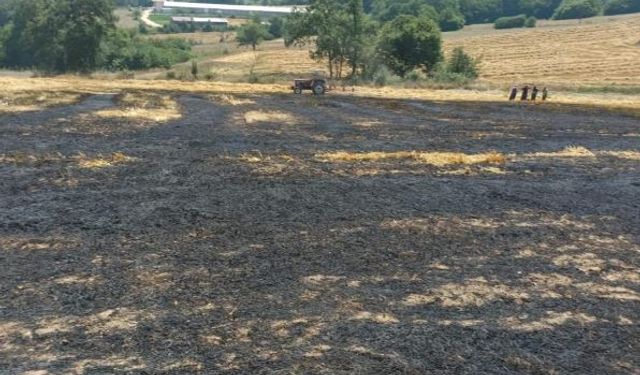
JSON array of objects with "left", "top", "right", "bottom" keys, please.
[{"left": 153, "top": 0, "right": 302, "bottom": 16}]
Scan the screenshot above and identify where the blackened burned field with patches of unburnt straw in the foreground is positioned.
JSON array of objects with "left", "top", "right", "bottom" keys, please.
[{"left": 0, "top": 92, "right": 640, "bottom": 374}]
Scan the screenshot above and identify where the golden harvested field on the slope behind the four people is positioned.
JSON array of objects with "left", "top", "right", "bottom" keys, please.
[{"left": 444, "top": 14, "right": 640, "bottom": 86}]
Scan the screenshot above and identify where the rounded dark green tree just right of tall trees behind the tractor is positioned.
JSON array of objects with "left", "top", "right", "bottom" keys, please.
[{"left": 377, "top": 16, "right": 442, "bottom": 77}]
